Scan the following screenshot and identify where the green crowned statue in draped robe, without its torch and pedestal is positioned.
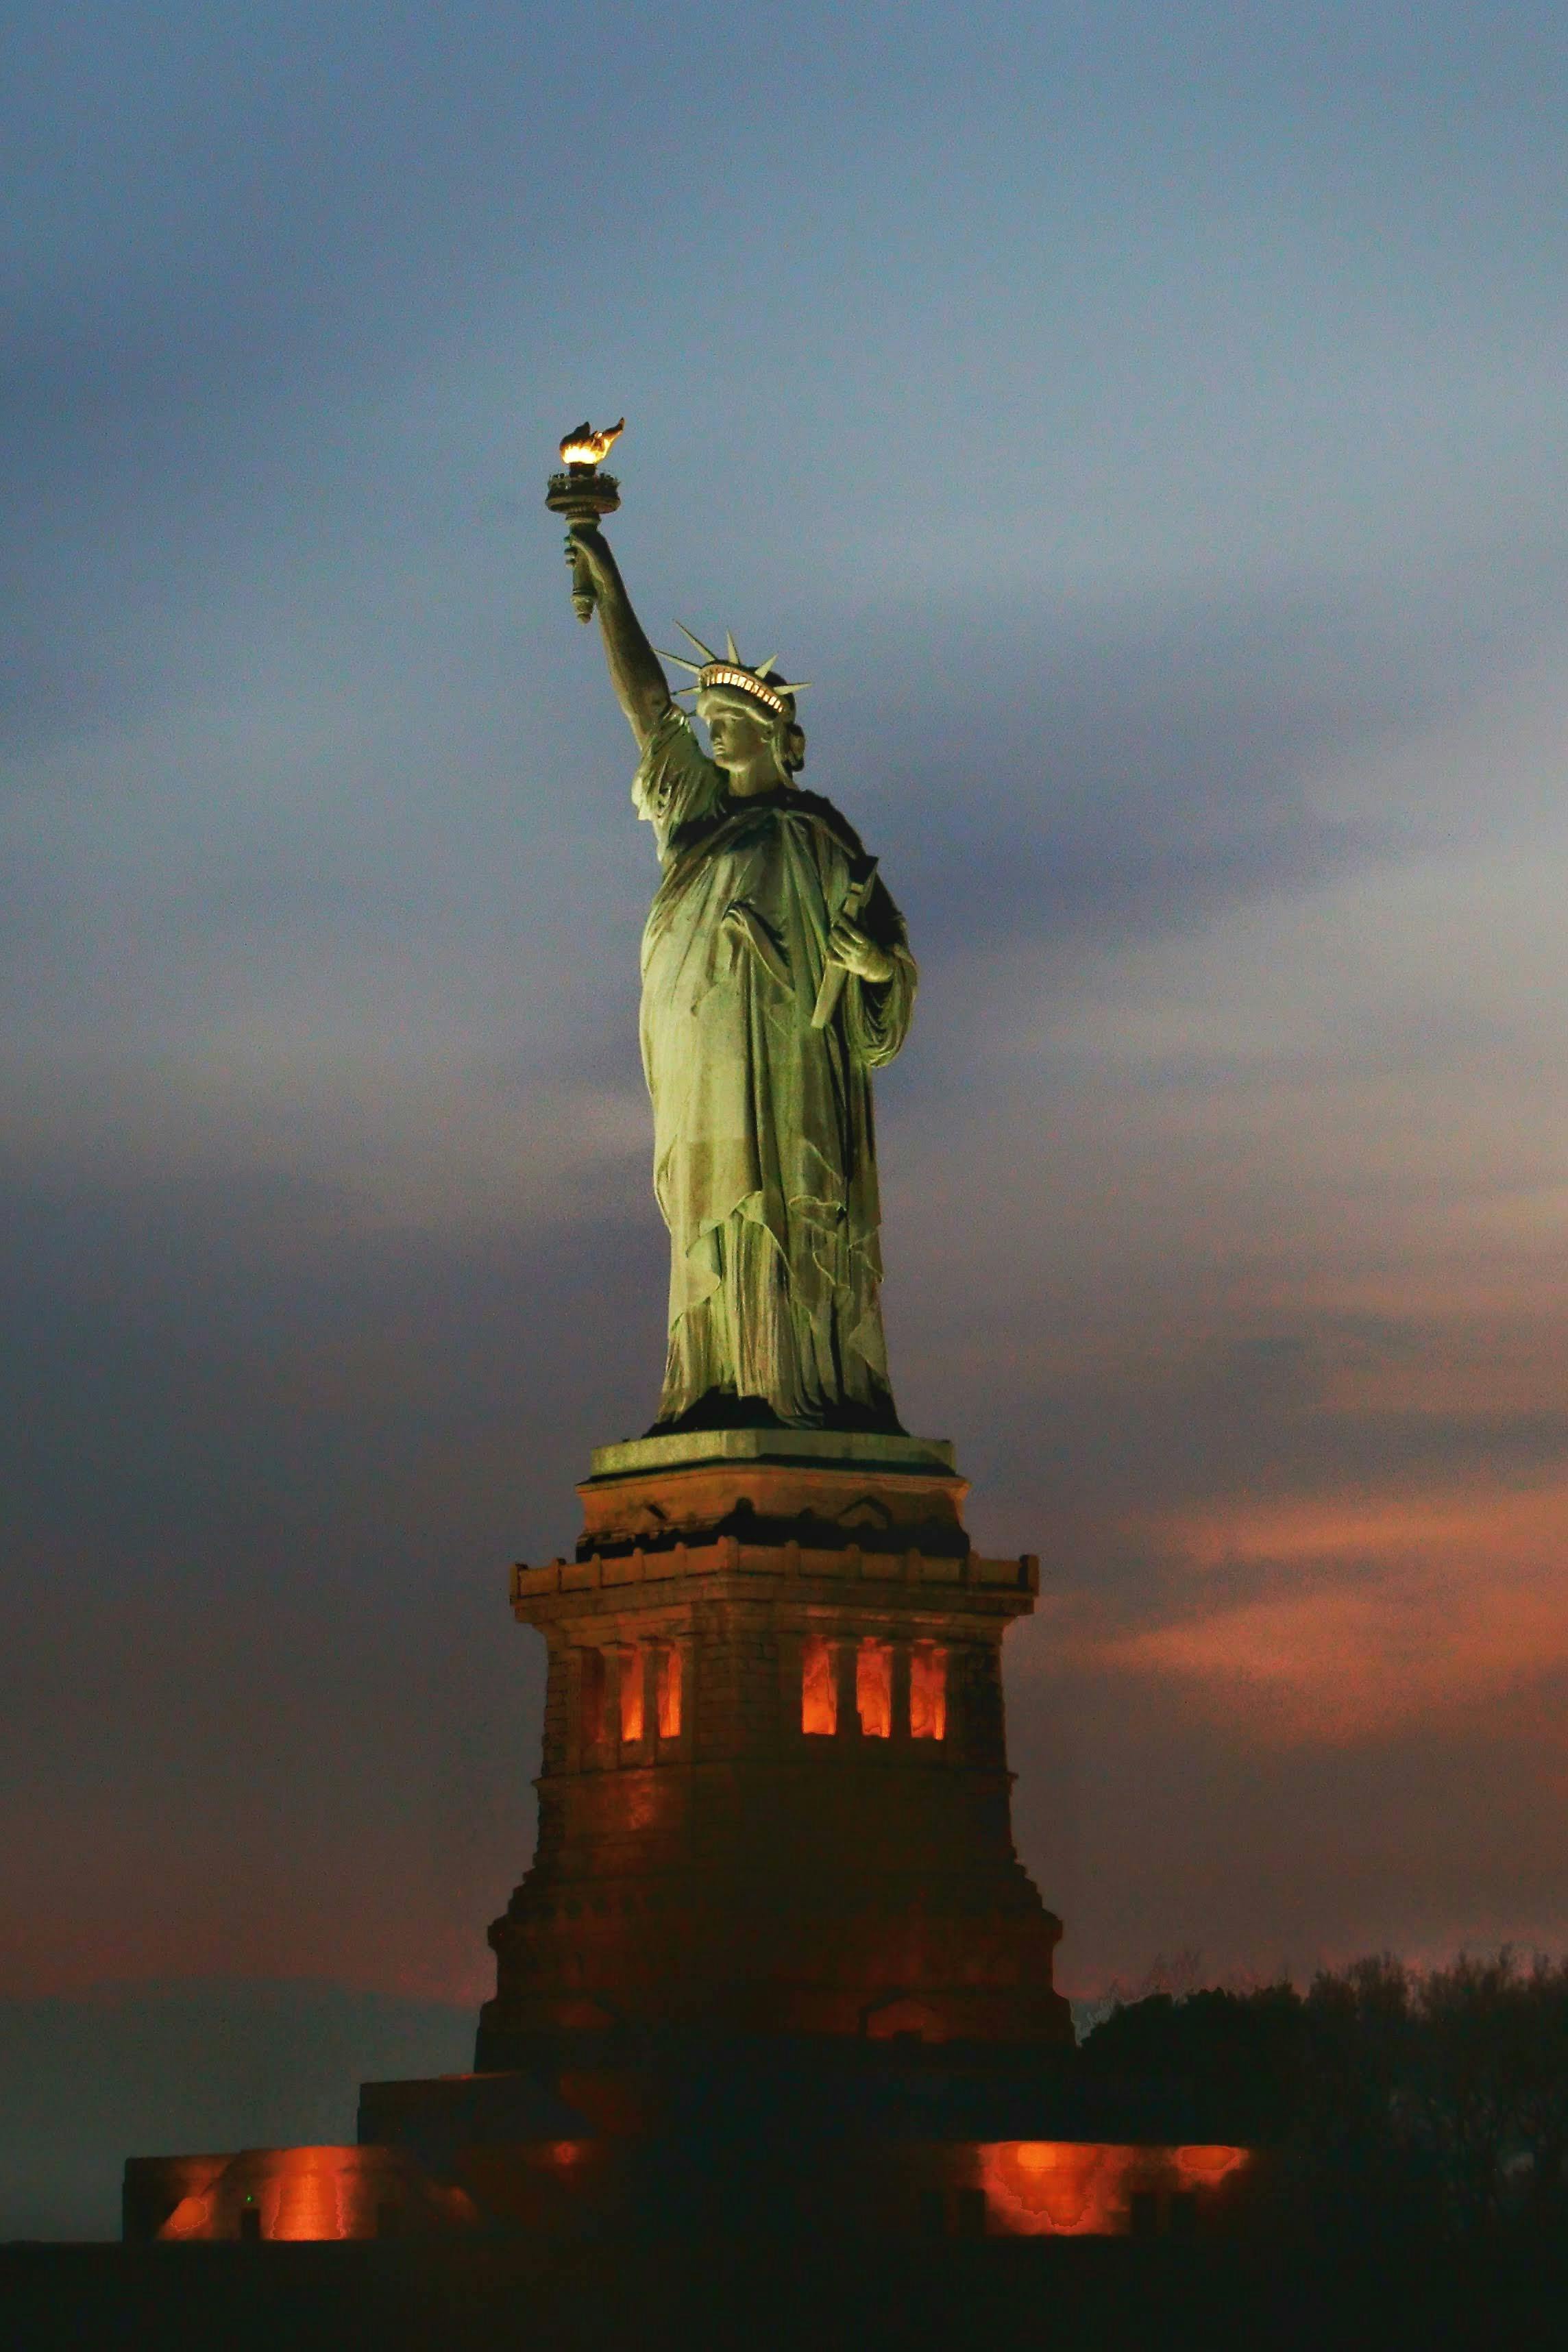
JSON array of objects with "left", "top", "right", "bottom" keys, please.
[{"left": 562, "top": 517, "right": 917, "bottom": 1435}]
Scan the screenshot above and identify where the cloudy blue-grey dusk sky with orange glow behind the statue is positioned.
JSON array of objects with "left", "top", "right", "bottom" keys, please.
[{"left": 0, "top": 0, "right": 1568, "bottom": 2234}]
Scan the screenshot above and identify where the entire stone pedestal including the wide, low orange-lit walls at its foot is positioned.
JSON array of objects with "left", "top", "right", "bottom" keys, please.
[{"left": 127, "top": 1430, "right": 1251, "bottom": 2253}]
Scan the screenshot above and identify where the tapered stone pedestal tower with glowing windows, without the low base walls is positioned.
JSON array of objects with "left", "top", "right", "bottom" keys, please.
[{"left": 477, "top": 1430, "right": 1070, "bottom": 2068}]
